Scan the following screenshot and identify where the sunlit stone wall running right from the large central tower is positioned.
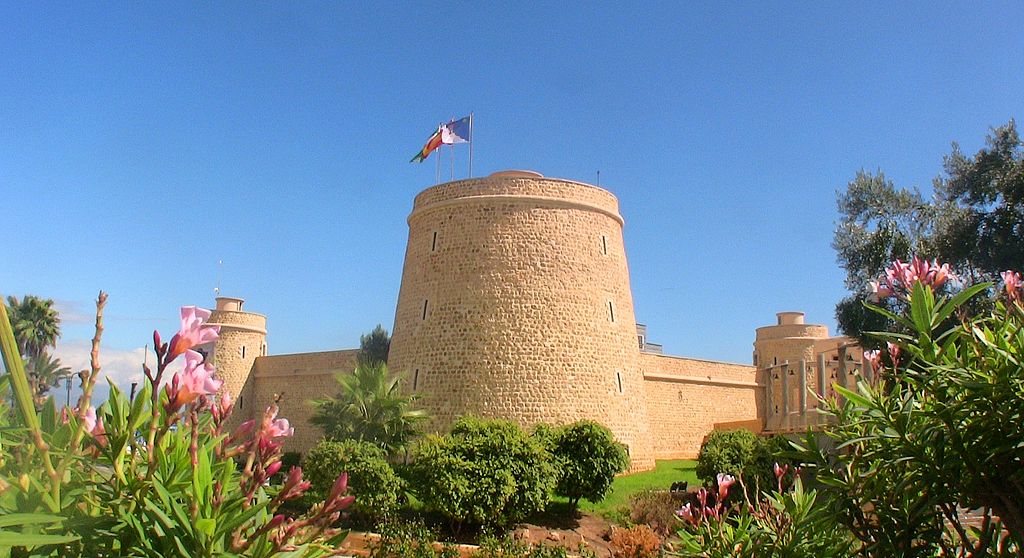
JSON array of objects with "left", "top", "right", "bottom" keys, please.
[{"left": 640, "top": 354, "right": 764, "bottom": 459}]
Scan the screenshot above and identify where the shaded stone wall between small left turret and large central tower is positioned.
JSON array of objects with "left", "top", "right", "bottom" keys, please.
[{"left": 251, "top": 349, "right": 359, "bottom": 454}]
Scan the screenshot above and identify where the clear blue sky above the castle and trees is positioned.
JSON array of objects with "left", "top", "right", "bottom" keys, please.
[{"left": 0, "top": 1, "right": 1024, "bottom": 391}]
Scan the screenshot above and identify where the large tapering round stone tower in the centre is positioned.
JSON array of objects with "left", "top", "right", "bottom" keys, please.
[{"left": 388, "top": 171, "right": 653, "bottom": 470}]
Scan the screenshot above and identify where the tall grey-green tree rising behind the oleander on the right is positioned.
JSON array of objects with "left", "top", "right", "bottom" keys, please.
[{"left": 833, "top": 120, "right": 1024, "bottom": 341}]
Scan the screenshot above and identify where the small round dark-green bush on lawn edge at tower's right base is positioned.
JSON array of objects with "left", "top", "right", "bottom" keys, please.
[{"left": 551, "top": 421, "right": 630, "bottom": 510}]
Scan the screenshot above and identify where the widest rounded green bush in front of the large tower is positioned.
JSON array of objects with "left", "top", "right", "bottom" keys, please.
[{"left": 412, "top": 417, "right": 556, "bottom": 526}]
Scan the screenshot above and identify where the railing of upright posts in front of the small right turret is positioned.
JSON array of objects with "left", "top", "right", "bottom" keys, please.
[{"left": 760, "top": 347, "right": 872, "bottom": 432}]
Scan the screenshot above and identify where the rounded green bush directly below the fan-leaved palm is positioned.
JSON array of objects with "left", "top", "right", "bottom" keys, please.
[{"left": 302, "top": 440, "right": 402, "bottom": 521}]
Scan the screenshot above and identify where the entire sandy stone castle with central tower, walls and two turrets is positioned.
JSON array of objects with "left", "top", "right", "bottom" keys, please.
[{"left": 210, "top": 171, "right": 863, "bottom": 470}]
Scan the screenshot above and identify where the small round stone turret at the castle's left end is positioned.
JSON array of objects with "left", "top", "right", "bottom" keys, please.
[{"left": 209, "top": 297, "right": 266, "bottom": 420}]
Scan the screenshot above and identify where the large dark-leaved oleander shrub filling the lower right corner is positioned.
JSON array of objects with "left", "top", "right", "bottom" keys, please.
[{"left": 808, "top": 264, "right": 1024, "bottom": 556}]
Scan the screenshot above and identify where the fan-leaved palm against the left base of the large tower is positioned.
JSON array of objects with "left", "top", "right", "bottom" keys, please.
[{"left": 309, "top": 362, "right": 427, "bottom": 455}]
